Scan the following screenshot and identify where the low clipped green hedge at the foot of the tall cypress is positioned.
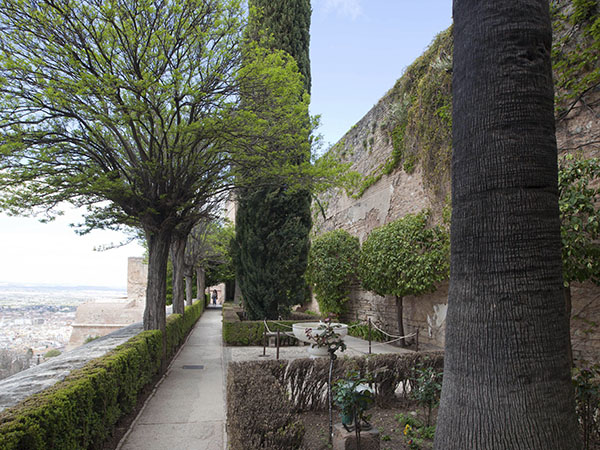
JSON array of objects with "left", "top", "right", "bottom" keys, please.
[{"left": 223, "top": 303, "right": 318, "bottom": 346}]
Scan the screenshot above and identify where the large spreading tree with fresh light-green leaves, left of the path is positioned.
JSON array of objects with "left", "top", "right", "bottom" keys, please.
[{"left": 0, "top": 0, "right": 310, "bottom": 342}]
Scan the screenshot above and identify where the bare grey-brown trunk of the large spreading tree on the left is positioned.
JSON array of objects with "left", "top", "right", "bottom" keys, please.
[{"left": 144, "top": 232, "right": 171, "bottom": 372}]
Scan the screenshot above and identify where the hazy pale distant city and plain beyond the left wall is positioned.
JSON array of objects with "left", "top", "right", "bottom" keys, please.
[{"left": 0, "top": 283, "right": 126, "bottom": 379}]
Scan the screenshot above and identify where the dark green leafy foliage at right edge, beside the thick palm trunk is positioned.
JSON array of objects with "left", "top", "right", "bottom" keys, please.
[{"left": 558, "top": 155, "right": 600, "bottom": 286}]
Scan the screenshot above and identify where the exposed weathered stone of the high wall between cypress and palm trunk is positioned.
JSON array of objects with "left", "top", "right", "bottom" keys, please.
[{"left": 313, "top": 86, "right": 448, "bottom": 348}]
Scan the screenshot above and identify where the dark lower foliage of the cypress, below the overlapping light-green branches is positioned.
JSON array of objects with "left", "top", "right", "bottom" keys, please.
[{"left": 234, "top": 187, "right": 311, "bottom": 320}]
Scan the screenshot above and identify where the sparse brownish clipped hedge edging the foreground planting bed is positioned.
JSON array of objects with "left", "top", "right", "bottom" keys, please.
[{"left": 227, "top": 352, "right": 444, "bottom": 450}]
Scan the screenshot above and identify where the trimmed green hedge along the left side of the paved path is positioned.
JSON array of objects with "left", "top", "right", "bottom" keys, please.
[{"left": 0, "top": 302, "right": 204, "bottom": 450}]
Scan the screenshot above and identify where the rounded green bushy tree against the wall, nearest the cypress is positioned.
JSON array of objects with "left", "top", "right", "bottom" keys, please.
[{"left": 306, "top": 230, "right": 360, "bottom": 314}]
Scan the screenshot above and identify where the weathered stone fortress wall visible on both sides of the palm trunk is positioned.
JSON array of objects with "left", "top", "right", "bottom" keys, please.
[{"left": 313, "top": 36, "right": 600, "bottom": 360}]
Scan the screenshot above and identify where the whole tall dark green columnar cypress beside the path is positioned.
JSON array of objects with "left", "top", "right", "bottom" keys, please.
[{"left": 235, "top": 0, "right": 311, "bottom": 319}]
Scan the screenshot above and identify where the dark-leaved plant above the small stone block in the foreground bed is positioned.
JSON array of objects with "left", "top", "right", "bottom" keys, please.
[{"left": 333, "top": 372, "right": 374, "bottom": 431}]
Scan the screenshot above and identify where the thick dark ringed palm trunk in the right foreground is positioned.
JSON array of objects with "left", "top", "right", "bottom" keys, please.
[{"left": 435, "top": 0, "right": 580, "bottom": 450}]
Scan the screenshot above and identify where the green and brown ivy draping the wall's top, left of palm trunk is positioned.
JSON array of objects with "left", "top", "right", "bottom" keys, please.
[{"left": 354, "top": 27, "right": 452, "bottom": 203}]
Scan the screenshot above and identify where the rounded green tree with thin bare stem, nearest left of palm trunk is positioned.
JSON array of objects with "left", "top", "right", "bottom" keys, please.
[{"left": 358, "top": 212, "right": 449, "bottom": 345}]
